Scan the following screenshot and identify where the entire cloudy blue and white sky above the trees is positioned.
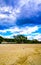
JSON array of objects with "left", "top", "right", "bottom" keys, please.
[{"left": 0, "top": 0, "right": 41, "bottom": 41}]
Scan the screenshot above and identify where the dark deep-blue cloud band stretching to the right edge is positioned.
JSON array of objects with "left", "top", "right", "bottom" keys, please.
[{"left": 16, "top": 15, "right": 41, "bottom": 26}]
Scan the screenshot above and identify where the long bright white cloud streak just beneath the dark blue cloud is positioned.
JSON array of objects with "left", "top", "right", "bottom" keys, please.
[{"left": 0, "top": 26, "right": 39, "bottom": 34}]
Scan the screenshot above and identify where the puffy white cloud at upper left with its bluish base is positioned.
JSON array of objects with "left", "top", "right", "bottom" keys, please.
[{"left": 0, "top": 6, "right": 20, "bottom": 28}]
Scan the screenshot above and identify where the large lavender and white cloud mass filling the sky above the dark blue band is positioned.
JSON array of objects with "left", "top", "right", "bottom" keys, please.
[{"left": 0, "top": 0, "right": 41, "bottom": 25}]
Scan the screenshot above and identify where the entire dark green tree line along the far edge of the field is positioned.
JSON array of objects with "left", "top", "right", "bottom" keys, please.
[{"left": 0, "top": 35, "right": 41, "bottom": 44}]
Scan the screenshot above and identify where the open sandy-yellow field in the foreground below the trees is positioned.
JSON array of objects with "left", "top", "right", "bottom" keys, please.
[{"left": 0, "top": 44, "right": 41, "bottom": 65}]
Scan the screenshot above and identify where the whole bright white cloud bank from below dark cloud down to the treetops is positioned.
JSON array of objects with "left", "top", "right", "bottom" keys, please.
[{"left": 0, "top": 26, "right": 41, "bottom": 41}]
